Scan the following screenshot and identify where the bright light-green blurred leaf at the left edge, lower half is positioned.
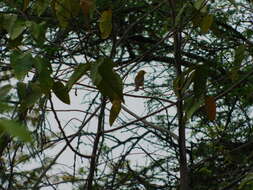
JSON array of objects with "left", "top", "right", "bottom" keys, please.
[{"left": 0, "top": 119, "right": 32, "bottom": 142}]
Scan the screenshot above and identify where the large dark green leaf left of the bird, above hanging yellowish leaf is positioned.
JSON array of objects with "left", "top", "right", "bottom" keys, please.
[{"left": 91, "top": 58, "right": 124, "bottom": 102}]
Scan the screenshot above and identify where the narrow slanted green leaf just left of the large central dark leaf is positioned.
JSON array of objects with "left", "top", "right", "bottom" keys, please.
[{"left": 67, "top": 63, "right": 90, "bottom": 90}]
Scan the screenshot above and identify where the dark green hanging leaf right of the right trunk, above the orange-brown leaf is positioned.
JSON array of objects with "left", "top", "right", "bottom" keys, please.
[{"left": 193, "top": 65, "right": 208, "bottom": 98}]
